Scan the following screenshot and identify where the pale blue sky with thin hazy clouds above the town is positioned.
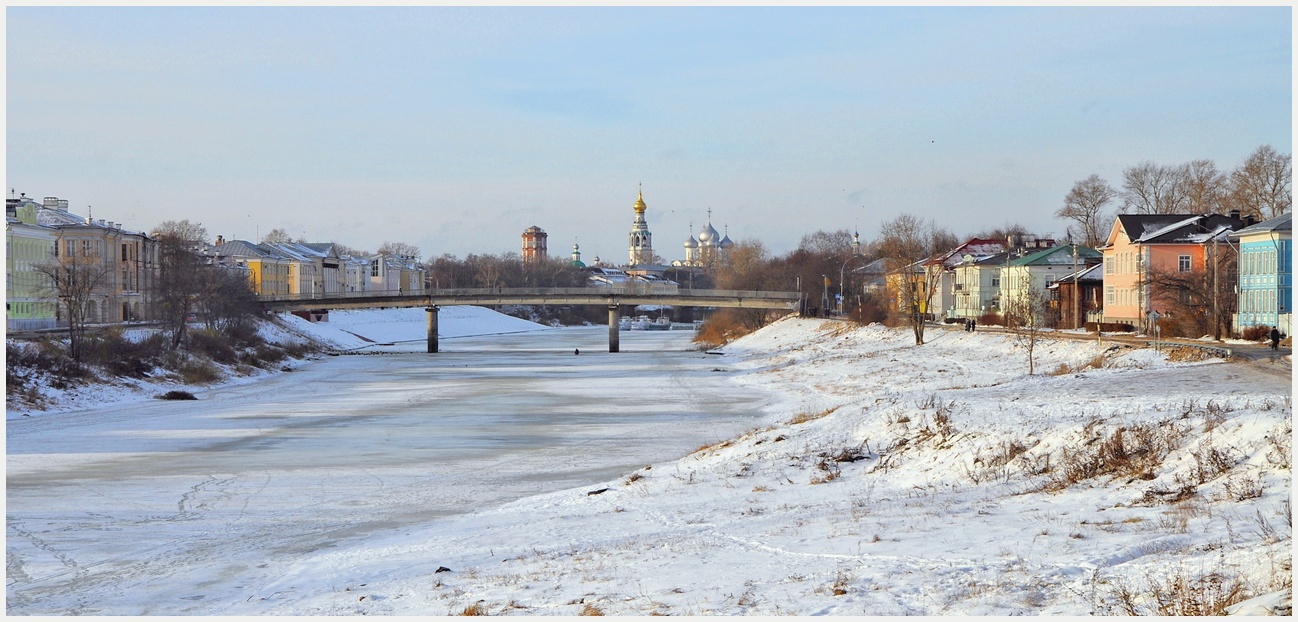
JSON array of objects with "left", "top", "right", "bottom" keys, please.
[{"left": 5, "top": 5, "right": 1293, "bottom": 264}]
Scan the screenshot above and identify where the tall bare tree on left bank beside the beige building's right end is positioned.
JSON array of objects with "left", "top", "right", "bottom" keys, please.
[{"left": 149, "top": 221, "right": 208, "bottom": 348}]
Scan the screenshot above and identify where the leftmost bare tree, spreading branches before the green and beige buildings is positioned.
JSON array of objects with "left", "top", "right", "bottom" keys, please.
[{"left": 32, "top": 236, "right": 112, "bottom": 362}]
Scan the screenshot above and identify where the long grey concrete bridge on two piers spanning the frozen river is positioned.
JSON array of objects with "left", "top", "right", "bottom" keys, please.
[{"left": 261, "top": 283, "right": 800, "bottom": 353}]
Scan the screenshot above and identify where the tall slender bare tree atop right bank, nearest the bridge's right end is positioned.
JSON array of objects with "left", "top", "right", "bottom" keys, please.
[{"left": 879, "top": 214, "right": 949, "bottom": 345}]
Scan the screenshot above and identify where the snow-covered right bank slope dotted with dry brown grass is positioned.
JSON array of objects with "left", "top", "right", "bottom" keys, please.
[{"left": 241, "top": 318, "right": 1292, "bottom": 616}]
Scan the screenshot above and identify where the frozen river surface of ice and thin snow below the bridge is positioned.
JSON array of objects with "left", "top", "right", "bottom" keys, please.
[{"left": 6, "top": 327, "right": 763, "bottom": 616}]
